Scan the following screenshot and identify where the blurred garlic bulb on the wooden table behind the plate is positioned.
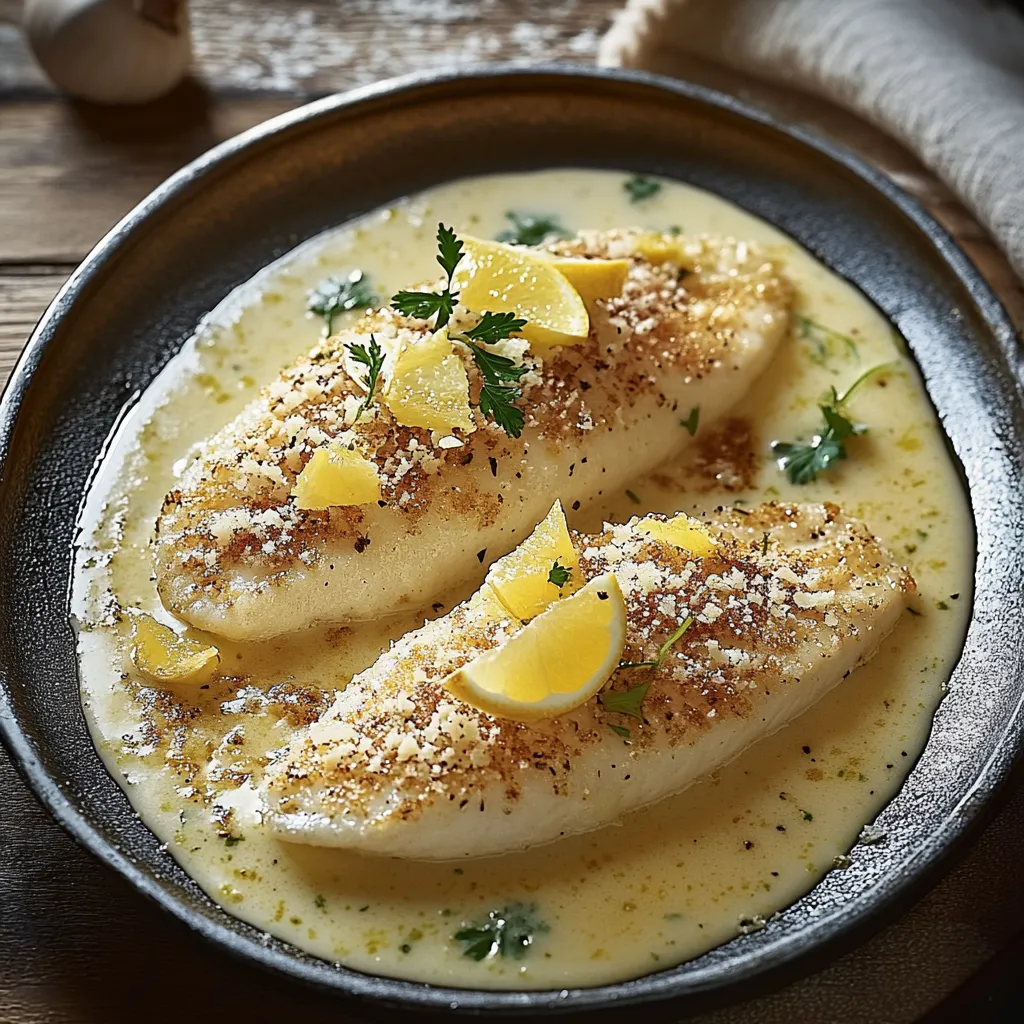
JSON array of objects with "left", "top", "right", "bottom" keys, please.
[{"left": 25, "top": 0, "right": 191, "bottom": 103}]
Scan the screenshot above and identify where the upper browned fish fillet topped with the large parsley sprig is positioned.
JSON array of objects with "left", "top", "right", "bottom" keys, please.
[{"left": 156, "top": 232, "right": 793, "bottom": 640}]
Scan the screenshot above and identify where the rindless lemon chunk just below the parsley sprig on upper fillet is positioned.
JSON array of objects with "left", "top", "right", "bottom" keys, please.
[{"left": 382, "top": 328, "right": 476, "bottom": 433}]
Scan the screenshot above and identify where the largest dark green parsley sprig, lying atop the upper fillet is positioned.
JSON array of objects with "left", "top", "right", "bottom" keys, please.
[{"left": 391, "top": 224, "right": 526, "bottom": 437}]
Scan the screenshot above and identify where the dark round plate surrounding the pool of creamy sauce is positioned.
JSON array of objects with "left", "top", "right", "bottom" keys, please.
[{"left": 0, "top": 68, "right": 1024, "bottom": 1016}]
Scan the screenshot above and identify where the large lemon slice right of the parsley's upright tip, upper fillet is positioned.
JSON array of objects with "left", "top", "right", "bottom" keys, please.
[{"left": 456, "top": 234, "right": 590, "bottom": 352}]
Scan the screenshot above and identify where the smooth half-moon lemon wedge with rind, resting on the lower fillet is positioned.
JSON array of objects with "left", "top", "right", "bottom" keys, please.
[{"left": 444, "top": 572, "right": 626, "bottom": 722}]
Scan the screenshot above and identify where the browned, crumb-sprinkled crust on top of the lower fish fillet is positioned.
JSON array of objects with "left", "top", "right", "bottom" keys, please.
[{"left": 269, "top": 504, "right": 914, "bottom": 820}]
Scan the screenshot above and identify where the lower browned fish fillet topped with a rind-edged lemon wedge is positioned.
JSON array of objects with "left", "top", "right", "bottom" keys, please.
[{"left": 263, "top": 505, "right": 914, "bottom": 859}]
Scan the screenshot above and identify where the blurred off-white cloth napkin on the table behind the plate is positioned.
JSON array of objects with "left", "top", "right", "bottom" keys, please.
[{"left": 598, "top": 0, "right": 1024, "bottom": 276}]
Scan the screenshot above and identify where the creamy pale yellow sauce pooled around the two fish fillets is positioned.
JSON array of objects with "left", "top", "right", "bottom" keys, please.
[{"left": 73, "top": 170, "right": 974, "bottom": 988}]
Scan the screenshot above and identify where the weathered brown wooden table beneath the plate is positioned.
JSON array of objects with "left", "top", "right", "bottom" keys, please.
[{"left": 0, "top": 0, "right": 1024, "bottom": 1024}]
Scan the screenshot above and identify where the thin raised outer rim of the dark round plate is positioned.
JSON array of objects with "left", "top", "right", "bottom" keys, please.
[{"left": 0, "top": 61, "right": 1024, "bottom": 1015}]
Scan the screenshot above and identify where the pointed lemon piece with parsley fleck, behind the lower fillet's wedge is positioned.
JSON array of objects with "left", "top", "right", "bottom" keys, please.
[{"left": 486, "top": 502, "right": 580, "bottom": 618}]
